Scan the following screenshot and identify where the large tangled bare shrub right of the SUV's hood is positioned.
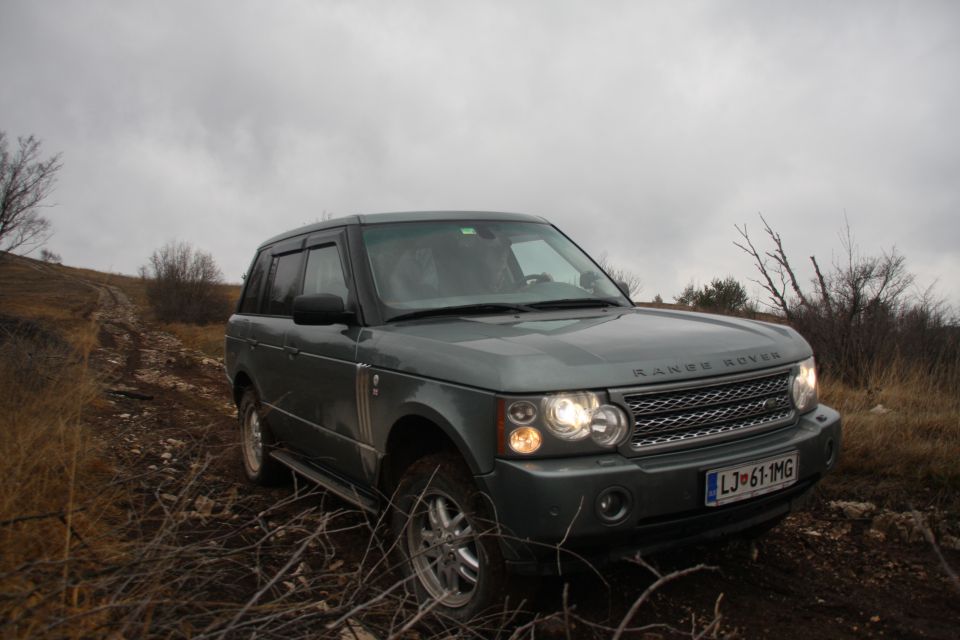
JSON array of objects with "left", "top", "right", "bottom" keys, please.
[{"left": 734, "top": 216, "right": 960, "bottom": 388}]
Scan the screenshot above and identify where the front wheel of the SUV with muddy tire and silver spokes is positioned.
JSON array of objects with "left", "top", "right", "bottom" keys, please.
[{"left": 391, "top": 454, "right": 505, "bottom": 622}]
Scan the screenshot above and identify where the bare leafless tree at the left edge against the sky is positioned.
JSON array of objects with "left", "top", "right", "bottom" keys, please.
[{"left": 0, "top": 131, "right": 62, "bottom": 252}]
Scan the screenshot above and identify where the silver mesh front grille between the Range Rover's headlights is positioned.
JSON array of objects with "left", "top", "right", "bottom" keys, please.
[{"left": 624, "top": 371, "right": 794, "bottom": 450}]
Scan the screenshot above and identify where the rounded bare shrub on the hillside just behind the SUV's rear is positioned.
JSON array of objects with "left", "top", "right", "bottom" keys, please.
[{"left": 140, "top": 242, "right": 229, "bottom": 324}]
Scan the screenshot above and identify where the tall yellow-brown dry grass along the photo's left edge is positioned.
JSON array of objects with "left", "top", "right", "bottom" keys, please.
[{"left": 0, "top": 317, "right": 122, "bottom": 637}]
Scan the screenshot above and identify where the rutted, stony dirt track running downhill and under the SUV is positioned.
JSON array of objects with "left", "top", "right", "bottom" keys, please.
[{"left": 88, "top": 283, "right": 960, "bottom": 640}]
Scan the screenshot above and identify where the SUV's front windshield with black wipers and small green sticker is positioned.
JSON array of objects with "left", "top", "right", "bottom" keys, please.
[{"left": 363, "top": 221, "right": 631, "bottom": 320}]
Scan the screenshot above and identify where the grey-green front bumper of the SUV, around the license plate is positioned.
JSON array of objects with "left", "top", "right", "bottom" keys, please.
[{"left": 476, "top": 405, "right": 841, "bottom": 573}]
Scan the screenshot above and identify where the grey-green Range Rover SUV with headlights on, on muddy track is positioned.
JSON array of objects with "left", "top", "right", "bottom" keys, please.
[{"left": 226, "top": 212, "right": 841, "bottom": 619}]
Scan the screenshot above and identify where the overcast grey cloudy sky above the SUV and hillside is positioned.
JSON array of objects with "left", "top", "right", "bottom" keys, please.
[{"left": 0, "top": 0, "right": 960, "bottom": 305}]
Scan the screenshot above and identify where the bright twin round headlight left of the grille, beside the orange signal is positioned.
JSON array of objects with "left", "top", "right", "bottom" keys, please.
[{"left": 543, "top": 392, "right": 628, "bottom": 447}]
